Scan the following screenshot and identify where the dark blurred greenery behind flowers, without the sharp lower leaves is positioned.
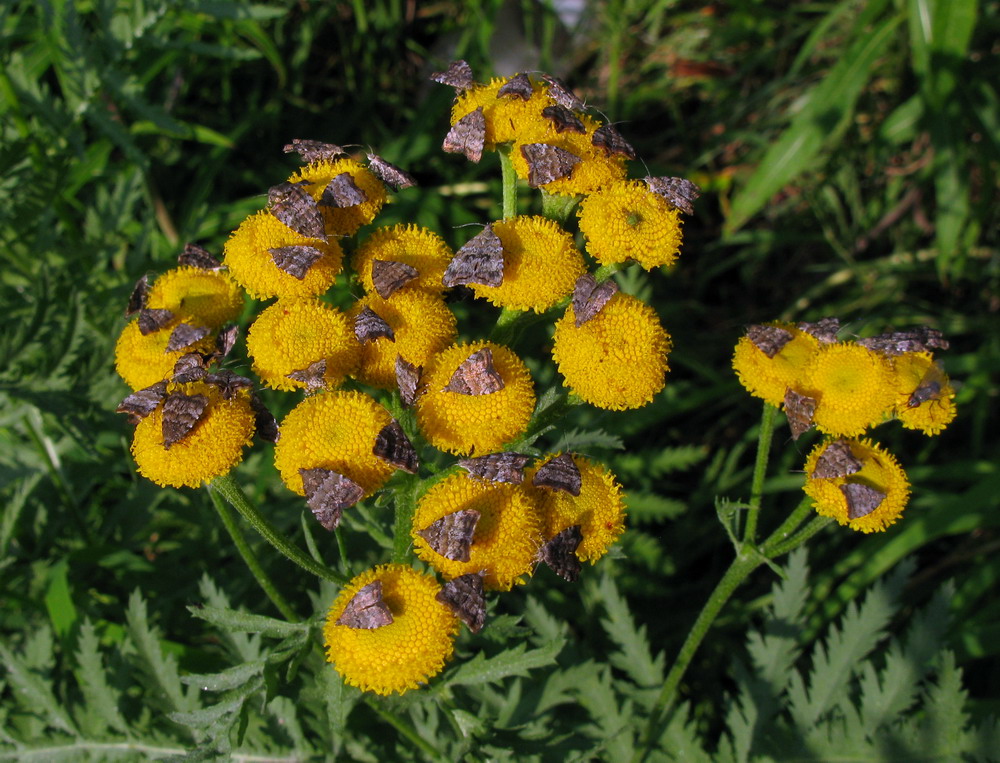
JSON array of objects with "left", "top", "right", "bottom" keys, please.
[{"left": 0, "top": 0, "right": 1000, "bottom": 752}]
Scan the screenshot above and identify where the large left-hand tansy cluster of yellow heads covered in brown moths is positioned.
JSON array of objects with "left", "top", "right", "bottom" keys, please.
[{"left": 116, "top": 62, "right": 696, "bottom": 694}]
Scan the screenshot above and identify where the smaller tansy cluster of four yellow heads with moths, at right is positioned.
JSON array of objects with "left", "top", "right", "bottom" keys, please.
[{"left": 733, "top": 318, "right": 955, "bottom": 533}]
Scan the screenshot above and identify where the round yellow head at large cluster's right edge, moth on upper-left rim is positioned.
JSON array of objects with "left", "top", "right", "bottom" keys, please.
[{"left": 552, "top": 293, "right": 670, "bottom": 410}]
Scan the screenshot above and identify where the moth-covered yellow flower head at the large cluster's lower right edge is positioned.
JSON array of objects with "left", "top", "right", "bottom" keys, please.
[{"left": 524, "top": 454, "right": 625, "bottom": 564}]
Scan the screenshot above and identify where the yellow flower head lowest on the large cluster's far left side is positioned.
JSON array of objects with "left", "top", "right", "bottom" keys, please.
[{"left": 132, "top": 381, "right": 255, "bottom": 487}]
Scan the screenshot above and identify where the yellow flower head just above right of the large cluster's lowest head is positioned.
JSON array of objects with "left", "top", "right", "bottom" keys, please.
[{"left": 413, "top": 472, "right": 542, "bottom": 591}]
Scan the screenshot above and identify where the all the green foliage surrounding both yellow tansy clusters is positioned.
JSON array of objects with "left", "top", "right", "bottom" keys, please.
[{"left": 0, "top": 0, "right": 1000, "bottom": 760}]
